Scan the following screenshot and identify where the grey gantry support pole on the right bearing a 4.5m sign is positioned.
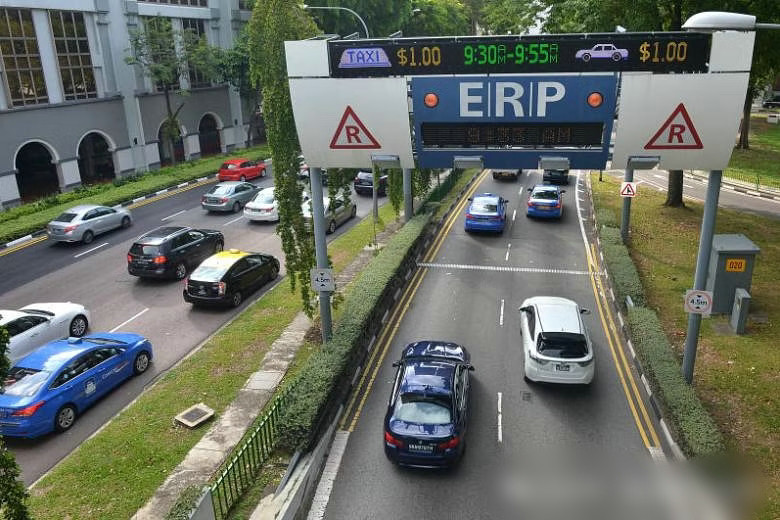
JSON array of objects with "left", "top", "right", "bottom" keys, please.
[{"left": 682, "top": 170, "right": 723, "bottom": 384}]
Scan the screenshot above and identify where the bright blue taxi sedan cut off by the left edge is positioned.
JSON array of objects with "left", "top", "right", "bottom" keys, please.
[{"left": 0, "top": 332, "right": 152, "bottom": 437}]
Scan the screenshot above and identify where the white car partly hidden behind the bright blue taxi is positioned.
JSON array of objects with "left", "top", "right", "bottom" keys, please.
[{"left": 0, "top": 302, "right": 90, "bottom": 366}]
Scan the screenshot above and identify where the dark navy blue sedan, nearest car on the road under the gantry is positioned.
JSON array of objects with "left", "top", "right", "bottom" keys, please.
[{"left": 385, "top": 341, "right": 474, "bottom": 468}]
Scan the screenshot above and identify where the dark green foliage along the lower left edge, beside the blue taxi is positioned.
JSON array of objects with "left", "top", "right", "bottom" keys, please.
[{"left": 0, "top": 327, "right": 30, "bottom": 520}]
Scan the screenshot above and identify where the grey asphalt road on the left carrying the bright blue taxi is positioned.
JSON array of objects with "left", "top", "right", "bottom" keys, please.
[{"left": 0, "top": 178, "right": 386, "bottom": 485}]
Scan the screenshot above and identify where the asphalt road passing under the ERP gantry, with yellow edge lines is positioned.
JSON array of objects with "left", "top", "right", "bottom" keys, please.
[{"left": 320, "top": 172, "right": 668, "bottom": 520}]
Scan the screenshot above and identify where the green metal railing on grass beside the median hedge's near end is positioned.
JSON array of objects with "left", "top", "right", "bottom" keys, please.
[{"left": 211, "top": 385, "right": 292, "bottom": 520}]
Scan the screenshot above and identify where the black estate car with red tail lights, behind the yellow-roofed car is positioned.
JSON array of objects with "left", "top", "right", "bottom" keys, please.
[{"left": 127, "top": 226, "right": 225, "bottom": 280}]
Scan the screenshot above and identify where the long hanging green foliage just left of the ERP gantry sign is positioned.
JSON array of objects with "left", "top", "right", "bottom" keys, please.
[{"left": 249, "top": 0, "right": 317, "bottom": 316}]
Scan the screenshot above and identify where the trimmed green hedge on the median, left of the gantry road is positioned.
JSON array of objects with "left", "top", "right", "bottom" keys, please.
[{"left": 277, "top": 213, "right": 432, "bottom": 450}]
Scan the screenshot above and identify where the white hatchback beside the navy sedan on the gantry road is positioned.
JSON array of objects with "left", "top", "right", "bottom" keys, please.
[{"left": 519, "top": 296, "right": 595, "bottom": 385}]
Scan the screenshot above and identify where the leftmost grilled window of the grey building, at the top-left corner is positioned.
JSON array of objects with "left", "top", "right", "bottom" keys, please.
[{"left": 0, "top": 9, "right": 49, "bottom": 107}]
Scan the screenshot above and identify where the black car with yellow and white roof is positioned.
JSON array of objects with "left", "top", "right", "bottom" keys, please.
[{"left": 184, "top": 249, "right": 279, "bottom": 307}]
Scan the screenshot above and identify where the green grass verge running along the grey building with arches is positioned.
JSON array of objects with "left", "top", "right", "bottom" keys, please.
[{"left": 0, "top": 145, "right": 270, "bottom": 243}]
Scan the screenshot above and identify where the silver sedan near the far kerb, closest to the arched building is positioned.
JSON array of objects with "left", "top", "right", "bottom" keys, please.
[{"left": 46, "top": 204, "right": 133, "bottom": 244}]
